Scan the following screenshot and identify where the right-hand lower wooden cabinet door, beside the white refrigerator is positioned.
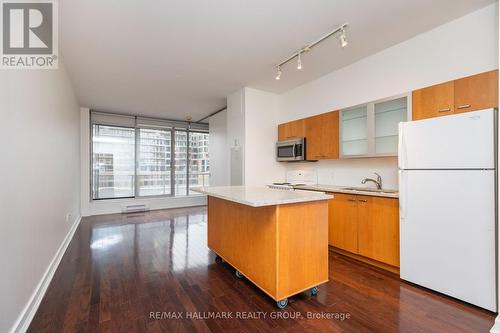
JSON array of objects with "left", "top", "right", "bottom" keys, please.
[{"left": 357, "top": 196, "right": 399, "bottom": 267}]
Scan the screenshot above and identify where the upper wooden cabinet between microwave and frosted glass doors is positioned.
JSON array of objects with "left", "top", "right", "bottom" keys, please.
[{"left": 305, "top": 111, "right": 339, "bottom": 160}]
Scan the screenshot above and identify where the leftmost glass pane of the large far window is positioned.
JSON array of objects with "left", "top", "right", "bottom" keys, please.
[{"left": 92, "top": 125, "right": 135, "bottom": 199}]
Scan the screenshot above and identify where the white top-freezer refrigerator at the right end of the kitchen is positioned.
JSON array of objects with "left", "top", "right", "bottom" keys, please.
[{"left": 398, "top": 109, "right": 497, "bottom": 311}]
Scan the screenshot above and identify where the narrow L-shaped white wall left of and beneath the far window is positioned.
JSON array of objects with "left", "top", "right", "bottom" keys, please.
[{"left": 80, "top": 108, "right": 207, "bottom": 216}]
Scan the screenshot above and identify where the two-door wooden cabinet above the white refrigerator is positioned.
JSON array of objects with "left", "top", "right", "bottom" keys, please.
[{"left": 412, "top": 70, "right": 498, "bottom": 120}]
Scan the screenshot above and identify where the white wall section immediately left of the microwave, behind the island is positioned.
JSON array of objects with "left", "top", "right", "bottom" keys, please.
[{"left": 244, "top": 88, "right": 285, "bottom": 186}]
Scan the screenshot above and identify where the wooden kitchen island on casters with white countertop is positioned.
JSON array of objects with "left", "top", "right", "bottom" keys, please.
[{"left": 198, "top": 186, "right": 332, "bottom": 308}]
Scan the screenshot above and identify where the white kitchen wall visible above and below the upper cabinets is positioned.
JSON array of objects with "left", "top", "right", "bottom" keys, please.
[{"left": 279, "top": 3, "right": 498, "bottom": 187}]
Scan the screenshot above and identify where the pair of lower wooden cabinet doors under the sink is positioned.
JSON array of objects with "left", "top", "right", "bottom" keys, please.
[{"left": 328, "top": 193, "right": 399, "bottom": 267}]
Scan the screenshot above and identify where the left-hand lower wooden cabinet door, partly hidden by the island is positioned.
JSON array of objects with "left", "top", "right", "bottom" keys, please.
[{"left": 328, "top": 193, "right": 358, "bottom": 253}]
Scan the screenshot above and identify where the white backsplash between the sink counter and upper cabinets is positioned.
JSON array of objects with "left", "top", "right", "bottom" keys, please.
[{"left": 286, "top": 157, "right": 398, "bottom": 189}]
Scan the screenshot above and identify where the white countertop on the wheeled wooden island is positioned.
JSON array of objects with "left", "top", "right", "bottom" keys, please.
[{"left": 193, "top": 186, "right": 333, "bottom": 207}]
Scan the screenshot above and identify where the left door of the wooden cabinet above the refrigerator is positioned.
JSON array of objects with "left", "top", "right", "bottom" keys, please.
[{"left": 412, "top": 81, "right": 454, "bottom": 120}]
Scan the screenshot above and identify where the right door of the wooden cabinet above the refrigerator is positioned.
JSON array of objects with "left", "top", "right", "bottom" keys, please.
[{"left": 454, "top": 70, "right": 498, "bottom": 113}]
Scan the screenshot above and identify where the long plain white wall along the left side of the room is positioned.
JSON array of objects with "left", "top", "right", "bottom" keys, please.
[{"left": 0, "top": 62, "right": 80, "bottom": 332}]
